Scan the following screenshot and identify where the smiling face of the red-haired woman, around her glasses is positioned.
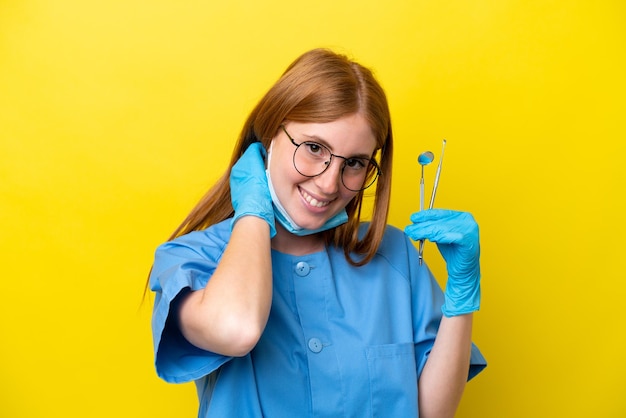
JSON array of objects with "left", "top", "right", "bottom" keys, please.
[{"left": 269, "top": 113, "right": 376, "bottom": 229}]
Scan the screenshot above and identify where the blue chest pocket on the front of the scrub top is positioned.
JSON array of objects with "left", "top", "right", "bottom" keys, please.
[{"left": 366, "top": 343, "right": 418, "bottom": 417}]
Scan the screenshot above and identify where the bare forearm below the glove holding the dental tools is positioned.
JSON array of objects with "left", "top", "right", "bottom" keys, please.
[{"left": 418, "top": 314, "right": 473, "bottom": 418}]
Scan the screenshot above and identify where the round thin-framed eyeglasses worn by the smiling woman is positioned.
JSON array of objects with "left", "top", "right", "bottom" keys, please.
[{"left": 280, "top": 125, "right": 380, "bottom": 192}]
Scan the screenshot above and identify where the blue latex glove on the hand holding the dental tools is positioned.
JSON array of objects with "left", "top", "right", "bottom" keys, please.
[{"left": 404, "top": 209, "right": 480, "bottom": 317}]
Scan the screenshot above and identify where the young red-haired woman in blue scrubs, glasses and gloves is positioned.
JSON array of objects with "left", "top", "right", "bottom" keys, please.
[{"left": 149, "top": 49, "right": 485, "bottom": 418}]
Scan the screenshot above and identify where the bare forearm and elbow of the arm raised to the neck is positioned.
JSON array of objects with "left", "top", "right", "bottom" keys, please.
[{"left": 179, "top": 216, "right": 272, "bottom": 356}]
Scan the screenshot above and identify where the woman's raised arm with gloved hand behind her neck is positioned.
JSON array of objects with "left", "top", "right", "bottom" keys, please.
[{"left": 178, "top": 143, "right": 276, "bottom": 356}]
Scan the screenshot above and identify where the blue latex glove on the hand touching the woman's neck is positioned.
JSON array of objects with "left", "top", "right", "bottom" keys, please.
[{"left": 230, "top": 142, "right": 276, "bottom": 237}]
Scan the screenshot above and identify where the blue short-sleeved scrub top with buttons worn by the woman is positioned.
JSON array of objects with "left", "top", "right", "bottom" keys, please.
[{"left": 150, "top": 220, "right": 486, "bottom": 418}]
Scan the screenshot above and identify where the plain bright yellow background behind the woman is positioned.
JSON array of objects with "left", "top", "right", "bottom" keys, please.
[{"left": 0, "top": 0, "right": 626, "bottom": 418}]
